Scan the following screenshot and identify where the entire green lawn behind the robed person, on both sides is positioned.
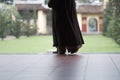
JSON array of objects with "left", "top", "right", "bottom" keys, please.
[{"left": 0, "top": 35, "right": 120, "bottom": 53}]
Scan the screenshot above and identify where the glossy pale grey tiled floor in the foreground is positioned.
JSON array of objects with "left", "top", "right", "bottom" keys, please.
[{"left": 0, "top": 53, "right": 120, "bottom": 80}]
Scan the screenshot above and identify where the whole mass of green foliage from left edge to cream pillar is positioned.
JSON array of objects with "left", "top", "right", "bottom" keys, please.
[{"left": 0, "top": 4, "right": 37, "bottom": 39}]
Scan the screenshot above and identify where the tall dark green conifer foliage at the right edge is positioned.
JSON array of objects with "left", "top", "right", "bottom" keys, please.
[{"left": 103, "top": 0, "right": 120, "bottom": 45}]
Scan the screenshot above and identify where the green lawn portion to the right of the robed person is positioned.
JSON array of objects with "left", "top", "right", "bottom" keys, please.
[{"left": 79, "top": 35, "right": 120, "bottom": 52}]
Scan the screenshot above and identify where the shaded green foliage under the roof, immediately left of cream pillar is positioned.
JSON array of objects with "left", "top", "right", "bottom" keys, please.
[{"left": 20, "top": 6, "right": 37, "bottom": 37}]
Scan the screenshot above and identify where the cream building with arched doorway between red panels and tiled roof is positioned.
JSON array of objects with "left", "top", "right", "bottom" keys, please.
[{"left": 77, "top": 4, "right": 103, "bottom": 34}]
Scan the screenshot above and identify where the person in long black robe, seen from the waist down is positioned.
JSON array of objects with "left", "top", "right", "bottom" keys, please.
[{"left": 48, "top": 0, "right": 84, "bottom": 54}]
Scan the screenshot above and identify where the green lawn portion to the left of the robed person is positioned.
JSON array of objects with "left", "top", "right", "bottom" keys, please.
[{"left": 0, "top": 36, "right": 53, "bottom": 53}]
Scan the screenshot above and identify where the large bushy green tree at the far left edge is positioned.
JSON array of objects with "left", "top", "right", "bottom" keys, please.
[{"left": 0, "top": 4, "right": 20, "bottom": 39}]
